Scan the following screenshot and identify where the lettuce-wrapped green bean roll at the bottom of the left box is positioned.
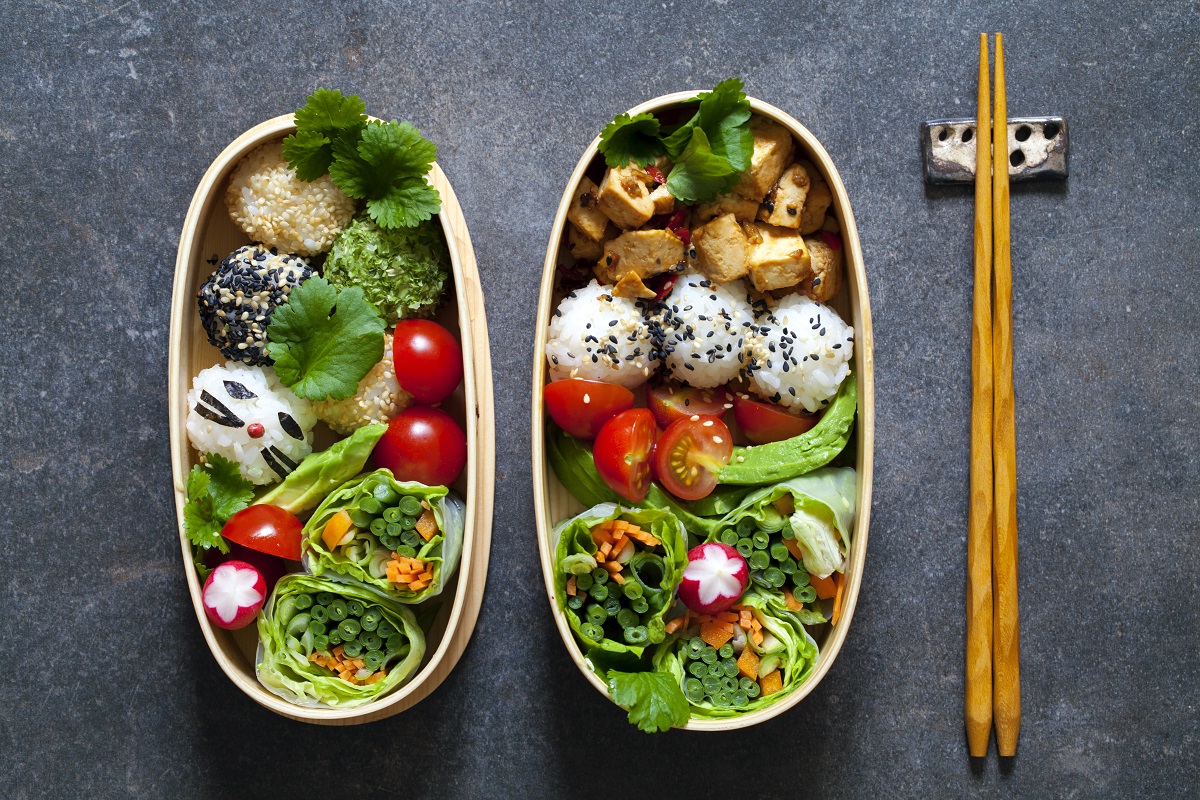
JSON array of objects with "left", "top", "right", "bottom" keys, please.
[{"left": 256, "top": 575, "right": 425, "bottom": 708}]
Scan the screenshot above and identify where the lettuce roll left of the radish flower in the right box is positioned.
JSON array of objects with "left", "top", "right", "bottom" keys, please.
[{"left": 554, "top": 503, "right": 688, "bottom": 658}]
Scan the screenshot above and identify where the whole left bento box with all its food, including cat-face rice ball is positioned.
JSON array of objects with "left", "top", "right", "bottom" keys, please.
[{"left": 169, "top": 89, "right": 494, "bottom": 724}]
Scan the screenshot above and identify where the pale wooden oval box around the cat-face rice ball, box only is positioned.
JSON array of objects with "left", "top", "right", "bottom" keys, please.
[{"left": 169, "top": 114, "right": 496, "bottom": 724}]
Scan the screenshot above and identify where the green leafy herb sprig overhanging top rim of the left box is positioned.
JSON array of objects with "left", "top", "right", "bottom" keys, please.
[{"left": 283, "top": 89, "right": 442, "bottom": 228}]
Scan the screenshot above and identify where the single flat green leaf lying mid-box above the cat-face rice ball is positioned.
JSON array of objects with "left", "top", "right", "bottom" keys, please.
[{"left": 266, "top": 277, "right": 384, "bottom": 401}]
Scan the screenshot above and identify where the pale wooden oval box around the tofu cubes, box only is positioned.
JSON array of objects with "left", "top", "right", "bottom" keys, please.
[{"left": 533, "top": 91, "right": 875, "bottom": 730}]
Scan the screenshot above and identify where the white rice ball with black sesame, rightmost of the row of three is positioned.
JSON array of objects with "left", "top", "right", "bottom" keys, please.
[{"left": 749, "top": 294, "right": 854, "bottom": 413}]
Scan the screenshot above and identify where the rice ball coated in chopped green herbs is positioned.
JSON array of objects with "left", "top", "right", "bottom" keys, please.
[{"left": 324, "top": 213, "right": 450, "bottom": 324}]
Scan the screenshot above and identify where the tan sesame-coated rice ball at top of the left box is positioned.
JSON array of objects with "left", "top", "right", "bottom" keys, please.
[{"left": 226, "top": 142, "right": 354, "bottom": 255}]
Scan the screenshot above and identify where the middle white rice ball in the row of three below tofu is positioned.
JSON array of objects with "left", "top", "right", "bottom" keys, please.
[{"left": 659, "top": 273, "right": 754, "bottom": 389}]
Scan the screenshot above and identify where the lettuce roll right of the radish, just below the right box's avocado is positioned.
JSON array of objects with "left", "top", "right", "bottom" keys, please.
[{"left": 708, "top": 467, "right": 856, "bottom": 625}]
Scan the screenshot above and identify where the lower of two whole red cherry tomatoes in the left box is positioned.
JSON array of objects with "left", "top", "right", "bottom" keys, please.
[{"left": 374, "top": 405, "right": 467, "bottom": 486}]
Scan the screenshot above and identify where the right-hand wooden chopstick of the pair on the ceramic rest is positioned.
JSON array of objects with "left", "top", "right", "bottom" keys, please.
[{"left": 991, "top": 34, "right": 1021, "bottom": 756}]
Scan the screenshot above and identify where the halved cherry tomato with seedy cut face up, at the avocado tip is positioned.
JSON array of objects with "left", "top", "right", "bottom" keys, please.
[{"left": 654, "top": 415, "right": 733, "bottom": 500}]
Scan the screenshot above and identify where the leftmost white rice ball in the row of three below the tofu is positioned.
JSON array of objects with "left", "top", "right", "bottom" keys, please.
[{"left": 546, "top": 281, "right": 659, "bottom": 389}]
